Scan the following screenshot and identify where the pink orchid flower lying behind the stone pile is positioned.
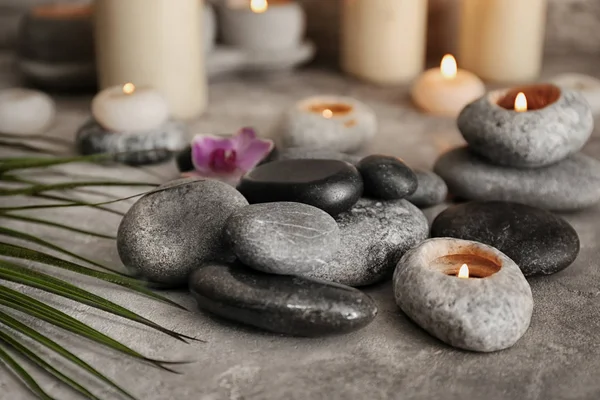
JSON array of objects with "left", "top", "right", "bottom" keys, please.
[{"left": 184, "top": 128, "right": 273, "bottom": 184}]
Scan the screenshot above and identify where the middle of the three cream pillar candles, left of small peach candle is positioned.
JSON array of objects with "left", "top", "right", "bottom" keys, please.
[{"left": 342, "top": 0, "right": 427, "bottom": 84}]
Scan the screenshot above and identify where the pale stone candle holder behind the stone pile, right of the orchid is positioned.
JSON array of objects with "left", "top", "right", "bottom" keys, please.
[{"left": 278, "top": 96, "right": 377, "bottom": 153}]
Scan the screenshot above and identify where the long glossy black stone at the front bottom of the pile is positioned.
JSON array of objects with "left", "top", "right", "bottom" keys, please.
[{"left": 190, "top": 263, "right": 377, "bottom": 336}]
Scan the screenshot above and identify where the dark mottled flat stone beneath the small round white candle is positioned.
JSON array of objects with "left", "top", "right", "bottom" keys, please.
[{"left": 75, "top": 119, "right": 187, "bottom": 165}]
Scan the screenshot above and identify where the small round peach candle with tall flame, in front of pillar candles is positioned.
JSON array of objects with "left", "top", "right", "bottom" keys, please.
[{"left": 411, "top": 54, "right": 485, "bottom": 117}]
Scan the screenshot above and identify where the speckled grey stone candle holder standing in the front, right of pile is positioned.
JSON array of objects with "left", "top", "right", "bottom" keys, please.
[{"left": 394, "top": 238, "right": 533, "bottom": 352}]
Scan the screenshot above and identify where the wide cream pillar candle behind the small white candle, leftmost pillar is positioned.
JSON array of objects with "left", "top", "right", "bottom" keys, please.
[{"left": 94, "top": 0, "right": 207, "bottom": 119}]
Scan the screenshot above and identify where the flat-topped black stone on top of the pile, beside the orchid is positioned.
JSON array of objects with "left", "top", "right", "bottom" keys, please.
[{"left": 238, "top": 160, "right": 363, "bottom": 215}]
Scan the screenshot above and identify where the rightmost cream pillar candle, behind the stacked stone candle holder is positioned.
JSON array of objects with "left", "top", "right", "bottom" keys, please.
[{"left": 459, "top": 0, "right": 546, "bottom": 82}]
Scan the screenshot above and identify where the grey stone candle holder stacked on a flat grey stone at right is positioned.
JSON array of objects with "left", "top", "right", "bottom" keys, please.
[{"left": 458, "top": 89, "right": 594, "bottom": 167}]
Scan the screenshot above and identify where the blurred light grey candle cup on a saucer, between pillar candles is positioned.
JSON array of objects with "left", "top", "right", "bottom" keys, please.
[{"left": 220, "top": 0, "right": 306, "bottom": 51}]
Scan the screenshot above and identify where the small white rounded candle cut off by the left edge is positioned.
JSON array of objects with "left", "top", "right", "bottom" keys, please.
[{"left": 0, "top": 88, "right": 56, "bottom": 135}]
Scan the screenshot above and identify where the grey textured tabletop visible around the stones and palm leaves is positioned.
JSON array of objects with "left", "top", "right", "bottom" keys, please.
[{"left": 0, "top": 55, "right": 600, "bottom": 400}]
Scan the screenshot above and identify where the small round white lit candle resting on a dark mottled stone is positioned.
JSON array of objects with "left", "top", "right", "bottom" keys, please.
[{"left": 92, "top": 83, "right": 169, "bottom": 132}]
